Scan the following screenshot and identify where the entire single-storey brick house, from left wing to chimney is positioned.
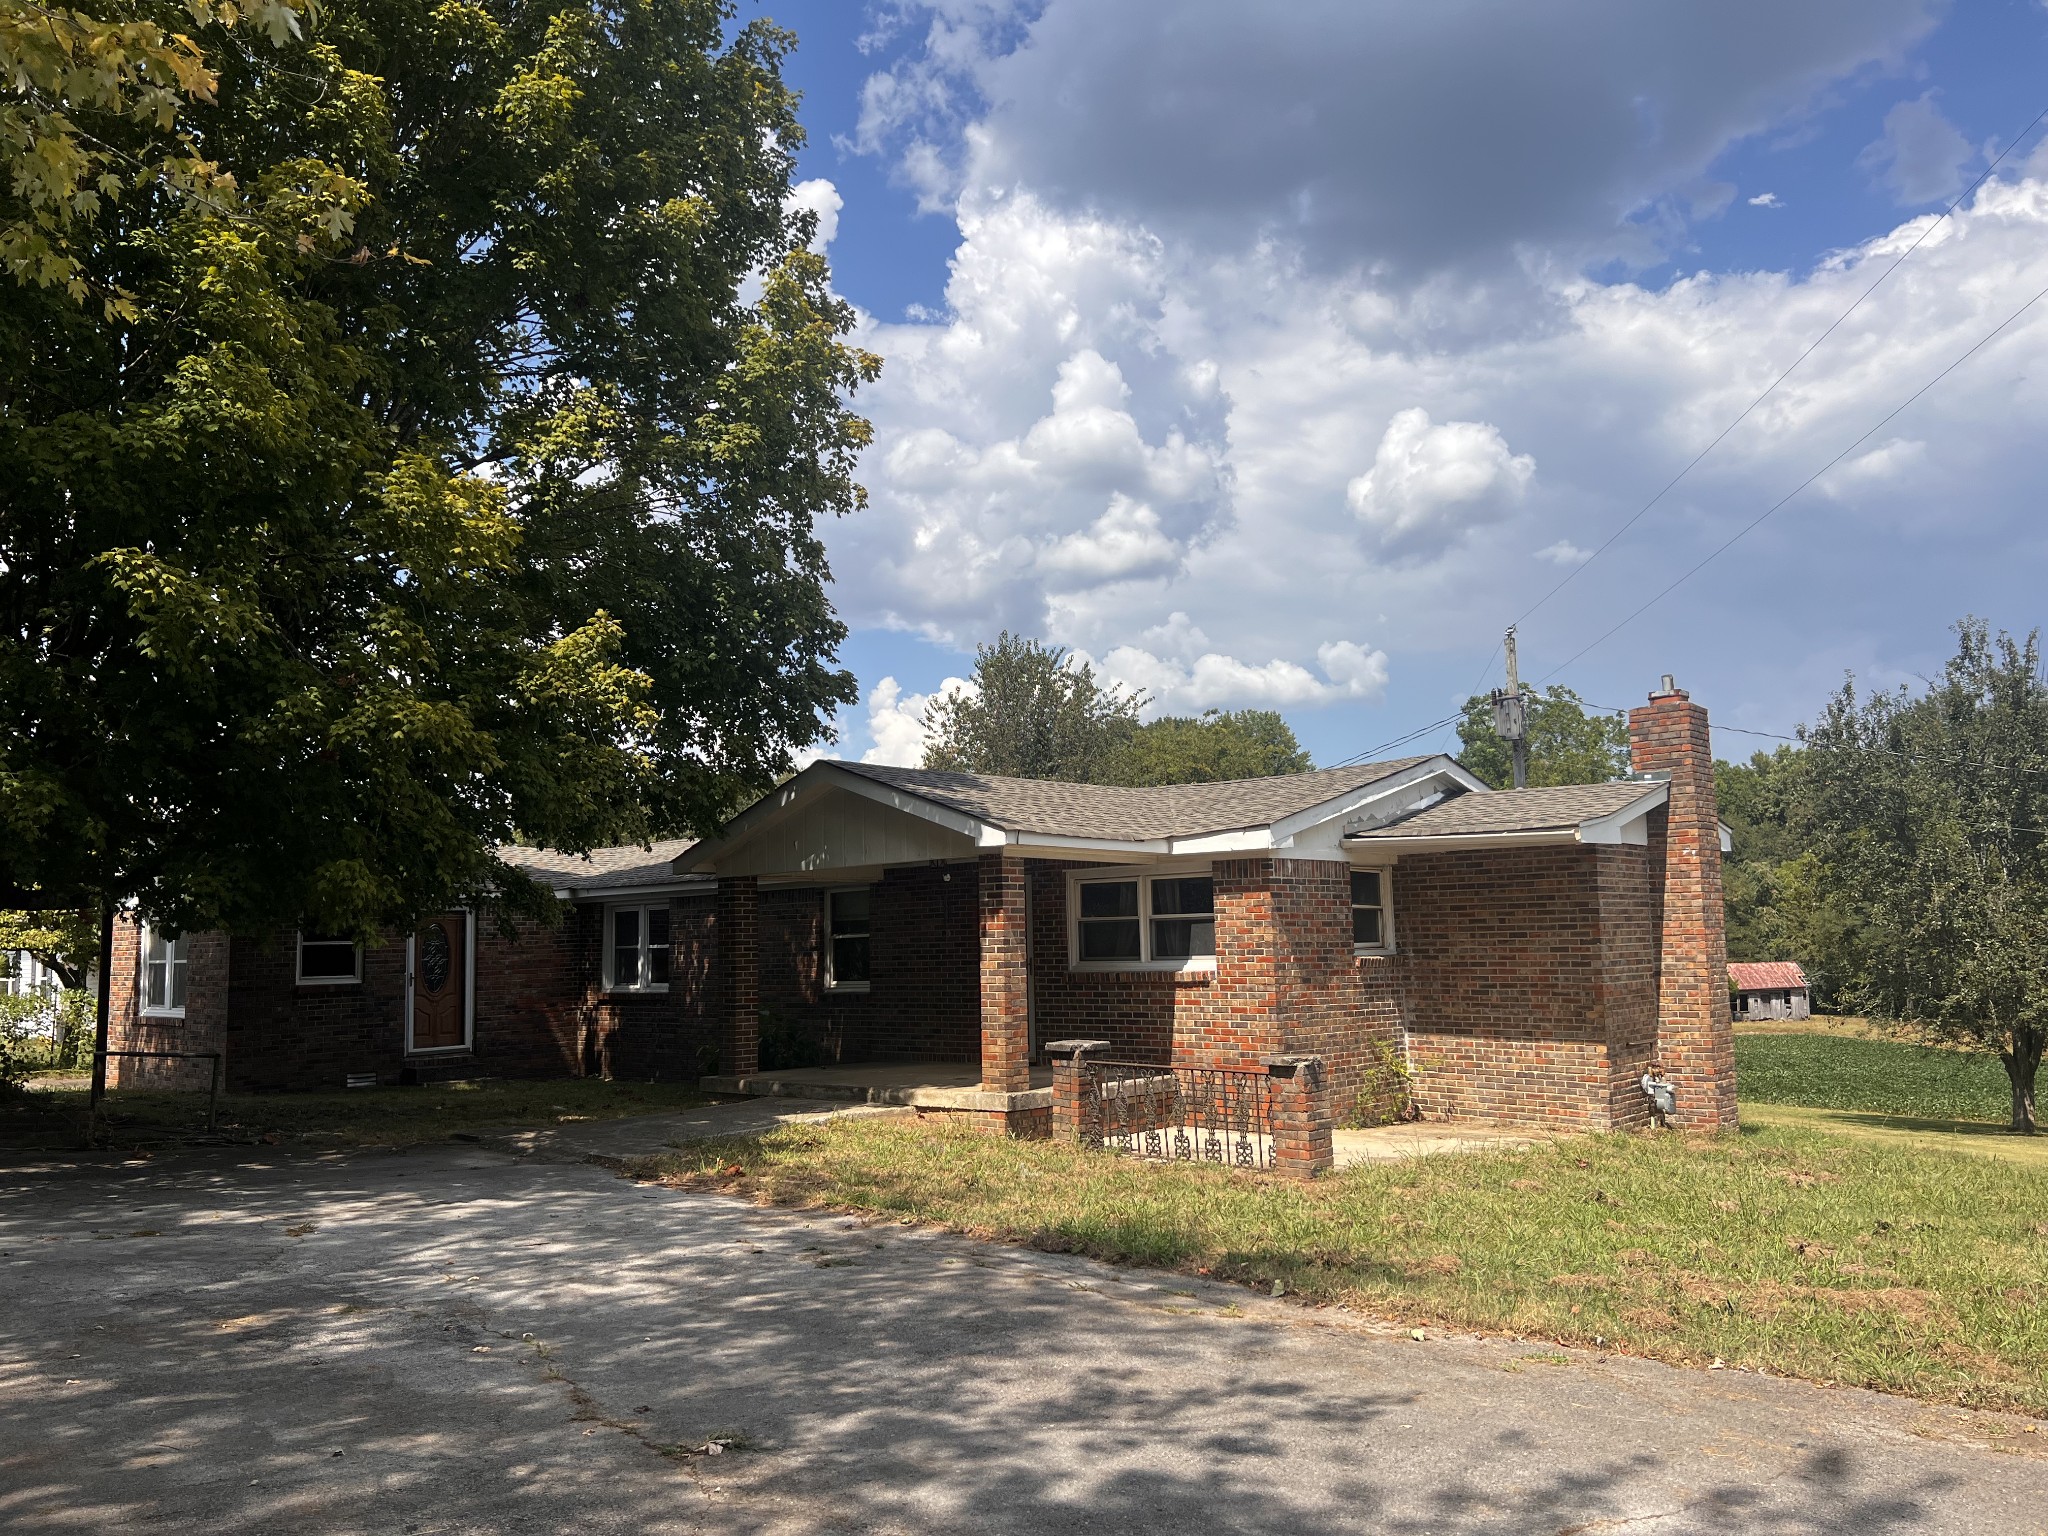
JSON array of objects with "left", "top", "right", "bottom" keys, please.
[{"left": 115, "top": 688, "right": 1735, "bottom": 1130}]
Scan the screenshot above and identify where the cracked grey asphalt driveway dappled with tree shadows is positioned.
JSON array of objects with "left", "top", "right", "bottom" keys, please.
[{"left": 0, "top": 1147, "right": 2048, "bottom": 1536}]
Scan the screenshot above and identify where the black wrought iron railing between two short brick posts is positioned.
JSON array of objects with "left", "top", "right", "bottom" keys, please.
[{"left": 1081, "top": 1061, "right": 1274, "bottom": 1169}]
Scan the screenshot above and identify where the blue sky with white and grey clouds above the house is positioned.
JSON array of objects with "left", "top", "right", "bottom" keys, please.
[{"left": 741, "top": 0, "right": 2048, "bottom": 762}]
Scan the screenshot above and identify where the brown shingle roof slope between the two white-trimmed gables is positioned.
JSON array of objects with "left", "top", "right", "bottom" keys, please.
[{"left": 834, "top": 756, "right": 1430, "bottom": 842}]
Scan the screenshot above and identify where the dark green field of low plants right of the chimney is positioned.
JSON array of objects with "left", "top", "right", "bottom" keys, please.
[{"left": 1735, "top": 1034, "right": 2011, "bottom": 1124}]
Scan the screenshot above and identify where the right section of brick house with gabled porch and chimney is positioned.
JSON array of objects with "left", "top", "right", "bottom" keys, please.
[{"left": 678, "top": 688, "right": 1735, "bottom": 1128}]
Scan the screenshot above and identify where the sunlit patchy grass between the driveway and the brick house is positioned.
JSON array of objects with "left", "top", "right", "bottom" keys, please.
[{"left": 633, "top": 1120, "right": 2048, "bottom": 1415}]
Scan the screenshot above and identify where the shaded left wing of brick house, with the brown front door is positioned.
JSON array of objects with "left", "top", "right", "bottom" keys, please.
[{"left": 109, "top": 840, "right": 711, "bottom": 1092}]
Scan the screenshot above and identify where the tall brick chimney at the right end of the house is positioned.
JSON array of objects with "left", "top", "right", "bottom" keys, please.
[{"left": 1628, "top": 678, "right": 1735, "bottom": 1130}]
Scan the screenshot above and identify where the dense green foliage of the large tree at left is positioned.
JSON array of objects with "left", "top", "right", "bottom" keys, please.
[{"left": 0, "top": 0, "right": 881, "bottom": 932}]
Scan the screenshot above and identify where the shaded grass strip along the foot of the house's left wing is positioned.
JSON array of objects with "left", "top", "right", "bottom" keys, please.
[{"left": 0, "top": 1077, "right": 707, "bottom": 1149}]
